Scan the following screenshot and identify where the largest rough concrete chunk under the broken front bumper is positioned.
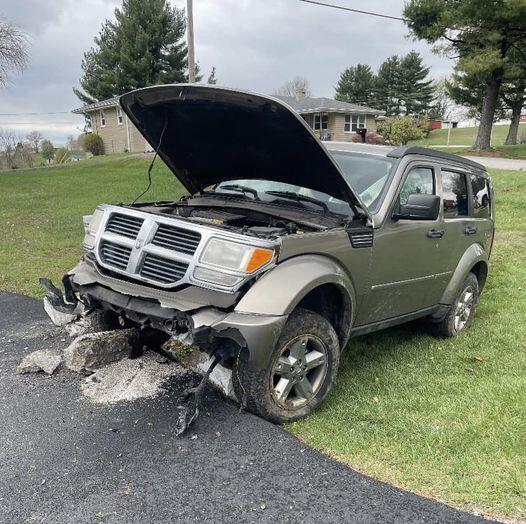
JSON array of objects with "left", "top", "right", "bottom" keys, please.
[{"left": 64, "top": 329, "right": 138, "bottom": 373}]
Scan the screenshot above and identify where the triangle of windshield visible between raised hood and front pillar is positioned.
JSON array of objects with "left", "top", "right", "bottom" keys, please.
[{"left": 329, "top": 151, "right": 394, "bottom": 211}]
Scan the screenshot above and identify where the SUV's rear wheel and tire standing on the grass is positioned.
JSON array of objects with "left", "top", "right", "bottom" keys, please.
[{"left": 432, "top": 273, "right": 480, "bottom": 337}]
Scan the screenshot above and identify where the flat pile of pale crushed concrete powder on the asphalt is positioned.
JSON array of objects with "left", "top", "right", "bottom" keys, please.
[{"left": 81, "top": 351, "right": 187, "bottom": 404}]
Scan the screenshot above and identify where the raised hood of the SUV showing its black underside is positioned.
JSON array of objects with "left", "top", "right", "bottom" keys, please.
[{"left": 120, "top": 84, "right": 364, "bottom": 209}]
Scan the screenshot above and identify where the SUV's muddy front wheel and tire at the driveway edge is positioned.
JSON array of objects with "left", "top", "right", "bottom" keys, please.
[{"left": 232, "top": 309, "right": 340, "bottom": 424}]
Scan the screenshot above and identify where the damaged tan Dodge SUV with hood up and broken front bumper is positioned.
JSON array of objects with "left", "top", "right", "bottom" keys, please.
[{"left": 57, "top": 84, "right": 493, "bottom": 422}]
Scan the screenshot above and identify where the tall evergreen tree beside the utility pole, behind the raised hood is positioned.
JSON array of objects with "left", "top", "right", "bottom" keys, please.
[{"left": 73, "top": 0, "right": 187, "bottom": 103}]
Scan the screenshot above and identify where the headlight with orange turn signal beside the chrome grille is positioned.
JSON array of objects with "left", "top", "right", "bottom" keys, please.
[{"left": 194, "top": 238, "right": 274, "bottom": 287}]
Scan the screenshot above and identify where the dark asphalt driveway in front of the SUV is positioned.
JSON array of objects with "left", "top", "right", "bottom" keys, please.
[{"left": 0, "top": 293, "right": 498, "bottom": 523}]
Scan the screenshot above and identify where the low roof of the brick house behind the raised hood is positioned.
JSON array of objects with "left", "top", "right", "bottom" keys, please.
[{"left": 72, "top": 92, "right": 385, "bottom": 115}]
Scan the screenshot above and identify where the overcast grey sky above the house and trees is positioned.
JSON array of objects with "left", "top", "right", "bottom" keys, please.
[{"left": 0, "top": 0, "right": 451, "bottom": 144}]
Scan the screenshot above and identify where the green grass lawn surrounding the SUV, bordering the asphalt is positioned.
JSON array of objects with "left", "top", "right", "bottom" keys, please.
[{"left": 0, "top": 158, "right": 526, "bottom": 518}]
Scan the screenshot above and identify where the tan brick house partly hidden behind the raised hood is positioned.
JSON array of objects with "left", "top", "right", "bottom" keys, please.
[{"left": 73, "top": 96, "right": 384, "bottom": 153}]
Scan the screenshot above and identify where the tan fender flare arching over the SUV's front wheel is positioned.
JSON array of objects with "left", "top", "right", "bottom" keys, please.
[{"left": 235, "top": 255, "right": 356, "bottom": 319}]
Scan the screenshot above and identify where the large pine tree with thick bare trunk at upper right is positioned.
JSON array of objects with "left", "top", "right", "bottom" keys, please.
[{"left": 404, "top": 0, "right": 526, "bottom": 149}]
